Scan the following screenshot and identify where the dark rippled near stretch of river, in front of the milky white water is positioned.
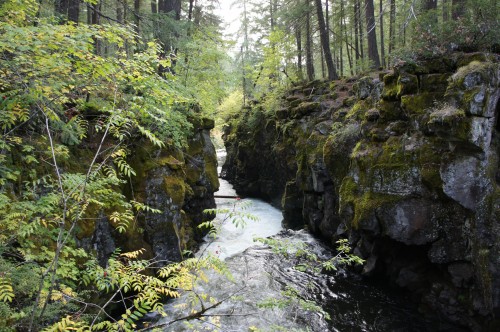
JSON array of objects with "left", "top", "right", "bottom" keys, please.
[{"left": 160, "top": 230, "right": 462, "bottom": 332}]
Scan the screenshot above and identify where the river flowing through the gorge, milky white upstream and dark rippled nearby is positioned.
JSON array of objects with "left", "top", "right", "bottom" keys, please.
[{"left": 160, "top": 152, "right": 447, "bottom": 332}]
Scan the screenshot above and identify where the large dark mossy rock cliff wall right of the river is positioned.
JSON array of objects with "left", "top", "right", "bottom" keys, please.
[{"left": 223, "top": 54, "right": 500, "bottom": 330}]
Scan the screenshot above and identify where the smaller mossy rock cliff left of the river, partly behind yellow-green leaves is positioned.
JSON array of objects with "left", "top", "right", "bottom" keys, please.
[{"left": 77, "top": 117, "right": 219, "bottom": 264}]
